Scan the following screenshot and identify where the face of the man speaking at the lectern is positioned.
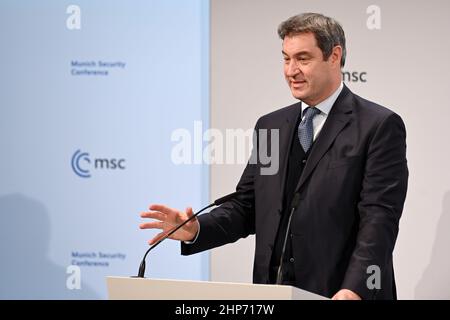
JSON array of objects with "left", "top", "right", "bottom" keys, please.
[{"left": 283, "top": 33, "right": 340, "bottom": 105}]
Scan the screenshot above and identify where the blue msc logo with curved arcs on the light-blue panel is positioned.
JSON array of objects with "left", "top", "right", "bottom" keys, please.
[{"left": 71, "top": 150, "right": 125, "bottom": 178}]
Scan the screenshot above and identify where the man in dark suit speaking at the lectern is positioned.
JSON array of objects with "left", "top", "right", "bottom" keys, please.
[{"left": 141, "top": 13, "right": 408, "bottom": 299}]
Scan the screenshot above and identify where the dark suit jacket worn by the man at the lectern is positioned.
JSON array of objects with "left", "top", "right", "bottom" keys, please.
[{"left": 181, "top": 86, "right": 408, "bottom": 299}]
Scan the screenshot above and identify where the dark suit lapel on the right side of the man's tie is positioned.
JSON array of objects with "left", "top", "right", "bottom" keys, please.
[{"left": 295, "top": 85, "right": 352, "bottom": 192}]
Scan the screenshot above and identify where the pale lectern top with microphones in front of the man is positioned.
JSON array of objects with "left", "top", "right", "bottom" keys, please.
[{"left": 106, "top": 277, "right": 328, "bottom": 300}]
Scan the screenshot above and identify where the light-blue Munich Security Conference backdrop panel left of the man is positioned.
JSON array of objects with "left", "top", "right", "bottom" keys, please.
[{"left": 0, "top": 0, "right": 209, "bottom": 299}]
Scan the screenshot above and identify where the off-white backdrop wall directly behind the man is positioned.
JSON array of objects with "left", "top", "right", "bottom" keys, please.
[{"left": 210, "top": 0, "right": 450, "bottom": 299}]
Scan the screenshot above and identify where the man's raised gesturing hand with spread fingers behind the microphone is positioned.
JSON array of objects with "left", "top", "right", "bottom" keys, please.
[{"left": 139, "top": 204, "right": 198, "bottom": 245}]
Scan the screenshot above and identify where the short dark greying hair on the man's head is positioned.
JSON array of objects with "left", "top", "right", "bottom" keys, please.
[{"left": 278, "top": 13, "right": 347, "bottom": 67}]
